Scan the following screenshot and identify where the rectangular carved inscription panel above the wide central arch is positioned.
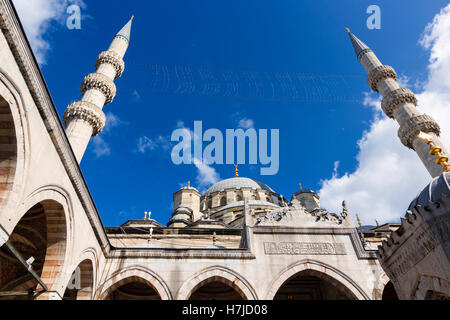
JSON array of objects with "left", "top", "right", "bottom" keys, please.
[{"left": 264, "top": 242, "right": 347, "bottom": 255}]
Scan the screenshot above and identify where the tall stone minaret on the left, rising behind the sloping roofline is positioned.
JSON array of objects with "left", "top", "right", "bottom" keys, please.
[{"left": 63, "top": 17, "right": 133, "bottom": 163}]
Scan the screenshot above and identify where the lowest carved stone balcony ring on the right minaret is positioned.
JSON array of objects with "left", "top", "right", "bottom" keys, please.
[{"left": 398, "top": 114, "right": 441, "bottom": 149}]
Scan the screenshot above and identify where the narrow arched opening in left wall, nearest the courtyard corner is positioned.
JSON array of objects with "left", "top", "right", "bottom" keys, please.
[{"left": 63, "top": 259, "right": 94, "bottom": 300}]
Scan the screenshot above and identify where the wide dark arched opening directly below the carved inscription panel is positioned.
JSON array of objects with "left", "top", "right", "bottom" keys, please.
[{"left": 274, "top": 270, "right": 356, "bottom": 300}]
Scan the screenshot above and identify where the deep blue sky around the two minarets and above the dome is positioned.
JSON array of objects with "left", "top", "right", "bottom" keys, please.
[{"left": 13, "top": 0, "right": 448, "bottom": 226}]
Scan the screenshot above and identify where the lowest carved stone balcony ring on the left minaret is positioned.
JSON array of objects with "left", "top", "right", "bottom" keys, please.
[{"left": 63, "top": 101, "right": 106, "bottom": 137}]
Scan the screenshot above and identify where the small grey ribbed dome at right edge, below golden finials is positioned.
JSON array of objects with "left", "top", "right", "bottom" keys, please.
[{"left": 408, "top": 172, "right": 450, "bottom": 210}]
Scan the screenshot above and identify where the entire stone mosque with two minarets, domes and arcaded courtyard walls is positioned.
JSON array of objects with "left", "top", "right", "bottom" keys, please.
[{"left": 0, "top": 0, "right": 450, "bottom": 300}]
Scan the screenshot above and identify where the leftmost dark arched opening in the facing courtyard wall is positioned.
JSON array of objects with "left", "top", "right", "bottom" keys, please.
[{"left": 105, "top": 277, "right": 161, "bottom": 300}]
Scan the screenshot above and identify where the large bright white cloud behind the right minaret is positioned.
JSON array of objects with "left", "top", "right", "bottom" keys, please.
[{"left": 319, "top": 5, "right": 450, "bottom": 224}]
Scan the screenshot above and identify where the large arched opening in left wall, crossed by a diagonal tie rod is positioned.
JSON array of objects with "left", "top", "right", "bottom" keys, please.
[{"left": 0, "top": 200, "right": 66, "bottom": 299}]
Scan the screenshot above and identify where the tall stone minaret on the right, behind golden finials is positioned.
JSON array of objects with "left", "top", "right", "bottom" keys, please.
[{"left": 347, "top": 29, "right": 449, "bottom": 177}]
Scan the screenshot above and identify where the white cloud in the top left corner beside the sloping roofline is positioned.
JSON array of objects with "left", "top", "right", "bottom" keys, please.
[{"left": 13, "top": 0, "right": 86, "bottom": 64}]
